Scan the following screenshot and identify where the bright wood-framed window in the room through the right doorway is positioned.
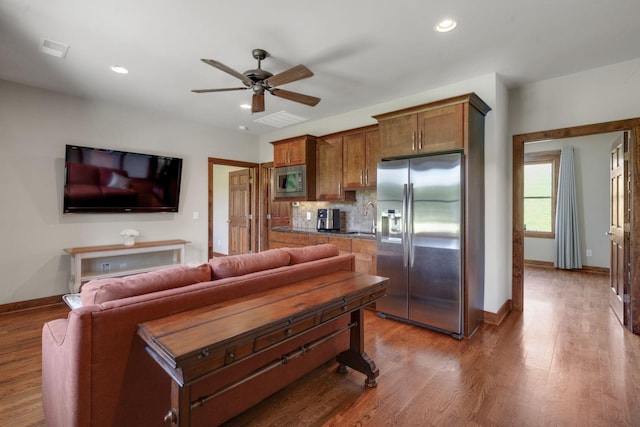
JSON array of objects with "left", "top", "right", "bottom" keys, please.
[{"left": 524, "top": 150, "right": 560, "bottom": 238}]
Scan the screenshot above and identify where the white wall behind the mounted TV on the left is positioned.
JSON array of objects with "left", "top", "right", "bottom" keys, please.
[{"left": 0, "top": 80, "right": 258, "bottom": 304}]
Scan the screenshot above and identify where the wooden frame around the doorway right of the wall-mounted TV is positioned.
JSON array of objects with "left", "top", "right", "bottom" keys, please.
[{"left": 207, "top": 157, "right": 260, "bottom": 259}]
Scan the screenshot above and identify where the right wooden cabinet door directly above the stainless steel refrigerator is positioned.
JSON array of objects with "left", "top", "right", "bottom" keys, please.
[{"left": 418, "top": 104, "right": 464, "bottom": 153}]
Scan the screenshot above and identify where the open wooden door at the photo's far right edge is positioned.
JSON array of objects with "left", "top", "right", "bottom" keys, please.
[{"left": 608, "top": 133, "right": 630, "bottom": 325}]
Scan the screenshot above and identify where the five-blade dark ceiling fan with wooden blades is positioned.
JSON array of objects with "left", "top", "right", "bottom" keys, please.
[{"left": 191, "top": 49, "right": 320, "bottom": 113}]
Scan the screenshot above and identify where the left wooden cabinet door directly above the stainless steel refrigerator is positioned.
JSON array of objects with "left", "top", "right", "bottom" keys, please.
[{"left": 378, "top": 114, "right": 418, "bottom": 158}]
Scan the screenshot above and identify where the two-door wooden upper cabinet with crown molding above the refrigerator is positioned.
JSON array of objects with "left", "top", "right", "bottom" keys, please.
[{"left": 375, "top": 93, "right": 490, "bottom": 159}]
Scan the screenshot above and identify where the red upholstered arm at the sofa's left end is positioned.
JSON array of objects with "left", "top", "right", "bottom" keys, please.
[{"left": 42, "top": 307, "right": 93, "bottom": 427}]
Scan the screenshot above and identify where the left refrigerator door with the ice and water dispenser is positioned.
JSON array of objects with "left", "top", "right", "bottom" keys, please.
[{"left": 376, "top": 160, "right": 409, "bottom": 319}]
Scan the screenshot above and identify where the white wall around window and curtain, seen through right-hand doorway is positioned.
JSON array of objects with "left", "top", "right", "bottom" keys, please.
[{"left": 524, "top": 132, "right": 621, "bottom": 268}]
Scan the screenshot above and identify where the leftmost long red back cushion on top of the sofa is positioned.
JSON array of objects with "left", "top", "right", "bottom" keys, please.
[{"left": 80, "top": 264, "right": 211, "bottom": 306}]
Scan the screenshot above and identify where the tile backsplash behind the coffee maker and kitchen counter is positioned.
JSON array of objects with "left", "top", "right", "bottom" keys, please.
[{"left": 292, "top": 190, "right": 376, "bottom": 232}]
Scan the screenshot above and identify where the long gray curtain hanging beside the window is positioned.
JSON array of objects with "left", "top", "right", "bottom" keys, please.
[{"left": 554, "top": 147, "right": 582, "bottom": 269}]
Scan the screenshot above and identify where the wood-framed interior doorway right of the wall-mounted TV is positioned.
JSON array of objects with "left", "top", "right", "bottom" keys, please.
[{"left": 208, "top": 157, "right": 260, "bottom": 258}]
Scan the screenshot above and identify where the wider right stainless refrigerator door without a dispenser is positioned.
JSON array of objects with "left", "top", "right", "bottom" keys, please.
[{"left": 408, "top": 153, "right": 462, "bottom": 334}]
